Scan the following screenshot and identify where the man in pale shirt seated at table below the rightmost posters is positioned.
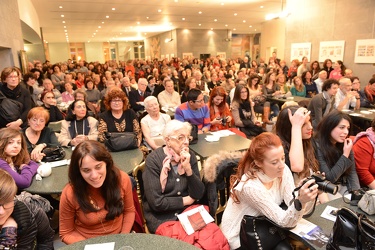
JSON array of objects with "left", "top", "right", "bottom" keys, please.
[{"left": 334, "top": 77, "right": 361, "bottom": 111}]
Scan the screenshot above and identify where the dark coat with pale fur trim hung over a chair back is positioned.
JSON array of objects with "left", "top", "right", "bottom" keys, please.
[{"left": 203, "top": 151, "right": 243, "bottom": 224}]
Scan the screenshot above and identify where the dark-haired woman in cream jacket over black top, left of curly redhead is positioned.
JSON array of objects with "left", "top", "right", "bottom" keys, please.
[{"left": 58, "top": 100, "right": 98, "bottom": 147}]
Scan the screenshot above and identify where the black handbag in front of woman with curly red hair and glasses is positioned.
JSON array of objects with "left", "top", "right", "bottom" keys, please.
[{"left": 104, "top": 132, "right": 138, "bottom": 152}]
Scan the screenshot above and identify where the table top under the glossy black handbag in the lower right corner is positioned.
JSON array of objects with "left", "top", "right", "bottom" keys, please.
[{"left": 298, "top": 198, "right": 375, "bottom": 250}]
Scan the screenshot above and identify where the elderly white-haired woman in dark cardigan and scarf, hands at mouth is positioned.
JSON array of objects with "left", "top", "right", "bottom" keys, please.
[{"left": 143, "top": 120, "right": 204, "bottom": 233}]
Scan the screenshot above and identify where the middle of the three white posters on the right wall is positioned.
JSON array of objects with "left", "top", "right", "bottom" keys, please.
[{"left": 319, "top": 41, "right": 345, "bottom": 62}]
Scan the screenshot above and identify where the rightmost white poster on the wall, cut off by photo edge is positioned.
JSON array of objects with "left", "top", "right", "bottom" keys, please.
[{"left": 354, "top": 39, "right": 375, "bottom": 63}]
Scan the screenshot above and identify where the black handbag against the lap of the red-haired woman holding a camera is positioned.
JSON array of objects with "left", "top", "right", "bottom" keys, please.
[{"left": 240, "top": 215, "right": 293, "bottom": 250}]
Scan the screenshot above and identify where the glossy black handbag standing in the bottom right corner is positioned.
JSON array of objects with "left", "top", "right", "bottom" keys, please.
[{"left": 327, "top": 207, "right": 375, "bottom": 250}]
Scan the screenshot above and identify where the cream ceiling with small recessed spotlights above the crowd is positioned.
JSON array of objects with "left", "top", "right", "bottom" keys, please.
[{"left": 31, "top": 0, "right": 286, "bottom": 43}]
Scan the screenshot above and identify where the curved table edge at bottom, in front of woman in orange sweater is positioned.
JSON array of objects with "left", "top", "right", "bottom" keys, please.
[{"left": 60, "top": 233, "right": 198, "bottom": 250}]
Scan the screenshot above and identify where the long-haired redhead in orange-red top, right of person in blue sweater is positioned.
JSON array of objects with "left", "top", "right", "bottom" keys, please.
[{"left": 208, "top": 86, "right": 233, "bottom": 131}]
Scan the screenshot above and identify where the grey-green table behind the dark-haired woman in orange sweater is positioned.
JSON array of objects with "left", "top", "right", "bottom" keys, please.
[{"left": 24, "top": 148, "right": 143, "bottom": 194}]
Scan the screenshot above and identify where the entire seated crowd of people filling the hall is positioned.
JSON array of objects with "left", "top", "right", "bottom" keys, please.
[{"left": 0, "top": 53, "right": 375, "bottom": 249}]
